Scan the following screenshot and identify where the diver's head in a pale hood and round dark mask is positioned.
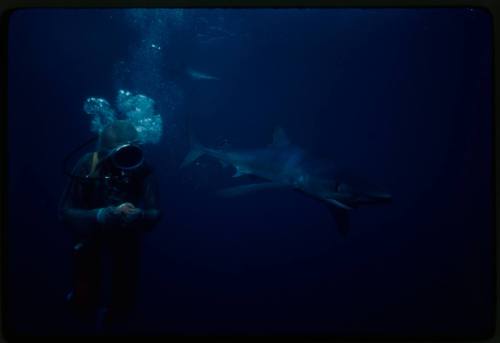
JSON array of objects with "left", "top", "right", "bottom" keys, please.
[{"left": 98, "top": 120, "right": 144, "bottom": 170}]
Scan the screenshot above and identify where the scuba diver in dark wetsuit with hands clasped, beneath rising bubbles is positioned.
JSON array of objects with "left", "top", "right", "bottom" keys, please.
[{"left": 59, "top": 120, "right": 160, "bottom": 330}]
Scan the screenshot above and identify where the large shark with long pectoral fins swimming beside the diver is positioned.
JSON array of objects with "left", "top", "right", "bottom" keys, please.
[{"left": 180, "top": 127, "right": 392, "bottom": 235}]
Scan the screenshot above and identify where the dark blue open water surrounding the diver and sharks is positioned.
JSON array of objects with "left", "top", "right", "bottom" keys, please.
[{"left": 6, "top": 9, "right": 493, "bottom": 337}]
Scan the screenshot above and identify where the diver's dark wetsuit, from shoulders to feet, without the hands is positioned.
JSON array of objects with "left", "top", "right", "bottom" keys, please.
[{"left": 59, "top": 153, "right": 160, "bottom": 328}]
